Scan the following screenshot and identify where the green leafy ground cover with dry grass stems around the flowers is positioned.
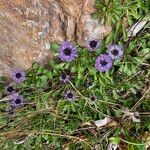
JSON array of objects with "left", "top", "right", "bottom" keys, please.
[{"left": 0, "top": 0, "right": 150, "bottom": 150}]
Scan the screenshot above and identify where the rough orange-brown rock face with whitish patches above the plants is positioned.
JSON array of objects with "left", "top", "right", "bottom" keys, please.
[{"left": 0, "top": 0, "right": 111, "bottom": 76}]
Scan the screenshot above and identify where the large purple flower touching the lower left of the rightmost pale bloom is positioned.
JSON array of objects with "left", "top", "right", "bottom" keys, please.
[{"left": 95, "top": 54, "right": 113, "bottom": 72}]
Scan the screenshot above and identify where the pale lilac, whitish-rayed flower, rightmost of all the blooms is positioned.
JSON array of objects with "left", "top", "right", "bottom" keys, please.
[{"left": 107, "top": 44, "right": 123, "bottom": 60}]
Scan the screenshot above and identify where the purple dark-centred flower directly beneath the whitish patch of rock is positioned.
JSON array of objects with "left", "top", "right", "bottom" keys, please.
[{"left": 86, "top": 39, "right": 102, "bottom": 51}]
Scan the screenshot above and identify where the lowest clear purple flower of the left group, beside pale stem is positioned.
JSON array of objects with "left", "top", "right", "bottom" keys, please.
[{"left": 9, "top": 93, "right": 24, "bottom": 108}]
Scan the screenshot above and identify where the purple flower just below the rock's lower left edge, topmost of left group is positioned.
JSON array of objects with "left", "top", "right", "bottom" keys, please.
[{"left": 12, "top": 69, "right": 26, "bottom": 83}]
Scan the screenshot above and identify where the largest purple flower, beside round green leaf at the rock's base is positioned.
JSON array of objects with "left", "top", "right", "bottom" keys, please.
[{"left": 59, "top": 41, "right": 78, "bottom": 61}]
